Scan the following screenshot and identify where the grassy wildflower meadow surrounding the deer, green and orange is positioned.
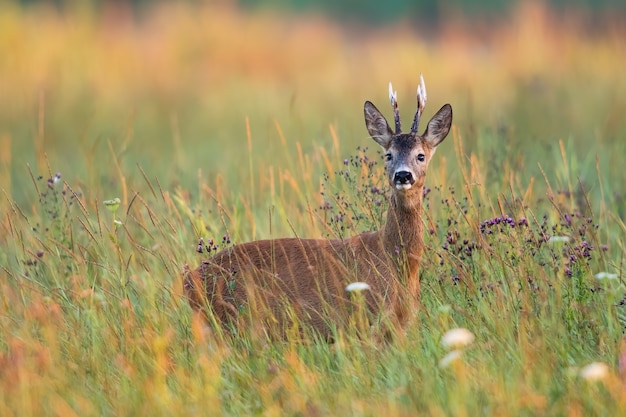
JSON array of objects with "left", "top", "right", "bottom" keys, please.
[{"left": 0, "top": 2, "right": 626, "bottom": 416}]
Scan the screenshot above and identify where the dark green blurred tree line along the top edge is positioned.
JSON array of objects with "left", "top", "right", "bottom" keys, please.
[{"left": 15, "top": 0, "right": 626, "bottom": 23}]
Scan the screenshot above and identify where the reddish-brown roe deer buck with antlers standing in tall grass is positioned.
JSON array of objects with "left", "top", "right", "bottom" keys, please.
[{"left": 185, "top": 75, "right": 452, "bottom": 340}]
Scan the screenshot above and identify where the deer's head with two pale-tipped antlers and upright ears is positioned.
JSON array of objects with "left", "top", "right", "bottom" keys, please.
[{"left": 364, "top": 75, "right": 452, "bottom": 195}]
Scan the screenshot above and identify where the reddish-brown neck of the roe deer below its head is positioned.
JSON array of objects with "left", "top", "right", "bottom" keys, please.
[{"left": 382, "top": 187, "right": 424, "bottom": 279}]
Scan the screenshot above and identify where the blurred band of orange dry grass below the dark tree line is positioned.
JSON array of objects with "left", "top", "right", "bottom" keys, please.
[{"left": 0, "top": 2, "right": 626, "bottom": 118}]
